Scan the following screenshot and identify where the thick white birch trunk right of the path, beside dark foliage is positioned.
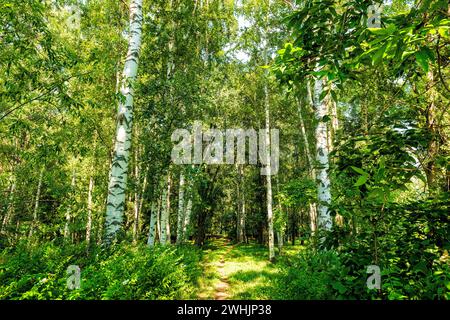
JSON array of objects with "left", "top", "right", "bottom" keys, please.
[{"left": 314, "top": 75, "right": 332, "bottom": 230}]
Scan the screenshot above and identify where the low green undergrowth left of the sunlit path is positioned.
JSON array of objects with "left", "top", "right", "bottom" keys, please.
[{"left": 0, "top": 243, "right": 200, "bottom": 299}]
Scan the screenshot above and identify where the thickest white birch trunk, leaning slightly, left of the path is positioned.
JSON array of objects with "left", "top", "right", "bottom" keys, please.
[{"left": 105, "top": 0, "right": 142, "bottom": 244}]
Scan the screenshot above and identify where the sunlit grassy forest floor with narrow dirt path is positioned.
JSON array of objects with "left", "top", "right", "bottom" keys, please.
[{"left": 198, "top": 238, "right": 301, "bottom": 300}]
